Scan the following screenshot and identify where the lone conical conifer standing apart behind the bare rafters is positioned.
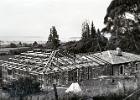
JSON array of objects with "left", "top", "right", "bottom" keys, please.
[{"left": 47, "top": 26, "right": 60, "bottom": 49}]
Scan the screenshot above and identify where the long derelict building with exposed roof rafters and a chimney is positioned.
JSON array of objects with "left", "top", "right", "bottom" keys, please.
[{"left": 1, "top": 50, "right": 140, "bottom": 86}]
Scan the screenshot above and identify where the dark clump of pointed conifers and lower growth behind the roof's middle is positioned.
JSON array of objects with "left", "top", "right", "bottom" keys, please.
[{"left": 63, "top": 21, "right": 107, "bottom": 54}]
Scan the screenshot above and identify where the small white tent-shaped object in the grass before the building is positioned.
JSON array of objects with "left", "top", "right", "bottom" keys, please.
[{"left": 65, "top": 83, "right": 82, "bottom": 93}]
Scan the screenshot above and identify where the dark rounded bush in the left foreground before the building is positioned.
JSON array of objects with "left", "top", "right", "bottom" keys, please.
[{"left": 7, "top": 77, "right": 40, "bottom": 97}]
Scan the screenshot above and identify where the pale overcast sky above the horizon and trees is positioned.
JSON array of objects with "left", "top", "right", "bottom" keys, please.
[{"left": 0, "top": 0, "right": 111, "bottom": 41}]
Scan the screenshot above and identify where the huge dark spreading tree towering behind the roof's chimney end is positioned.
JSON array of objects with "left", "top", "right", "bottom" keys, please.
[{"left": 102, "top": 0, "right": 140, "bottom": 52}]
